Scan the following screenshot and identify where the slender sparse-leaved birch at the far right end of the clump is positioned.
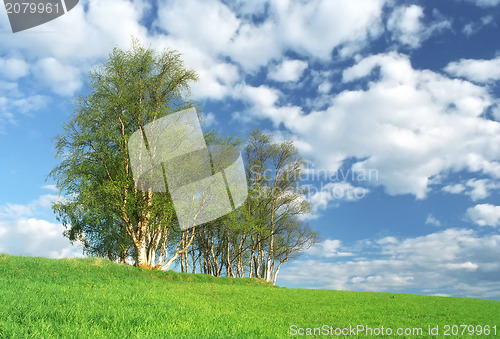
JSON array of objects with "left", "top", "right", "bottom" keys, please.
[{"left": 245, "top": 130, "right": 319, "bottom": 283}]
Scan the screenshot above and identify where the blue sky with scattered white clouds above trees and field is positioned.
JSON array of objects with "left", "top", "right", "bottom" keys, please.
[{"left": 0, "top": 0, "right": 500, "bottom": 300}]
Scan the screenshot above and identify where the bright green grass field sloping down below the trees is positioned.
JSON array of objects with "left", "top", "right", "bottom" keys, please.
[{"left": 0, "top": 255, "right": 500, "bottom": 338}]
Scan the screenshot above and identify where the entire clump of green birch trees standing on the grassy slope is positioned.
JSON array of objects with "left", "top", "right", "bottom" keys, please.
[{"left": 49, "top": 40, "right": 319, "bottom": 283}]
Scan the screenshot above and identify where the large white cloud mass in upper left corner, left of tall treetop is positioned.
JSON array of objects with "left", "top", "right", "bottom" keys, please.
[{"left": 0, "top": 0, "right": 149, "bottom": 128}]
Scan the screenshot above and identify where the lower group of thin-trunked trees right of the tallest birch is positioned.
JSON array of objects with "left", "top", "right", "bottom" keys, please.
[{"left": 181, "top": 130, "right": 319, "bottom": 283}]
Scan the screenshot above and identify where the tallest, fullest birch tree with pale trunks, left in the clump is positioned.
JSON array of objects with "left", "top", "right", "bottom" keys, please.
[{"left": 49, "top": 39, "right": 198, "bottom": 269}]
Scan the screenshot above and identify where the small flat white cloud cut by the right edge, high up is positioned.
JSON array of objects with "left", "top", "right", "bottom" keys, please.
[{"left": 444, "top": 57, "right": 500, "bottom": 83}]
